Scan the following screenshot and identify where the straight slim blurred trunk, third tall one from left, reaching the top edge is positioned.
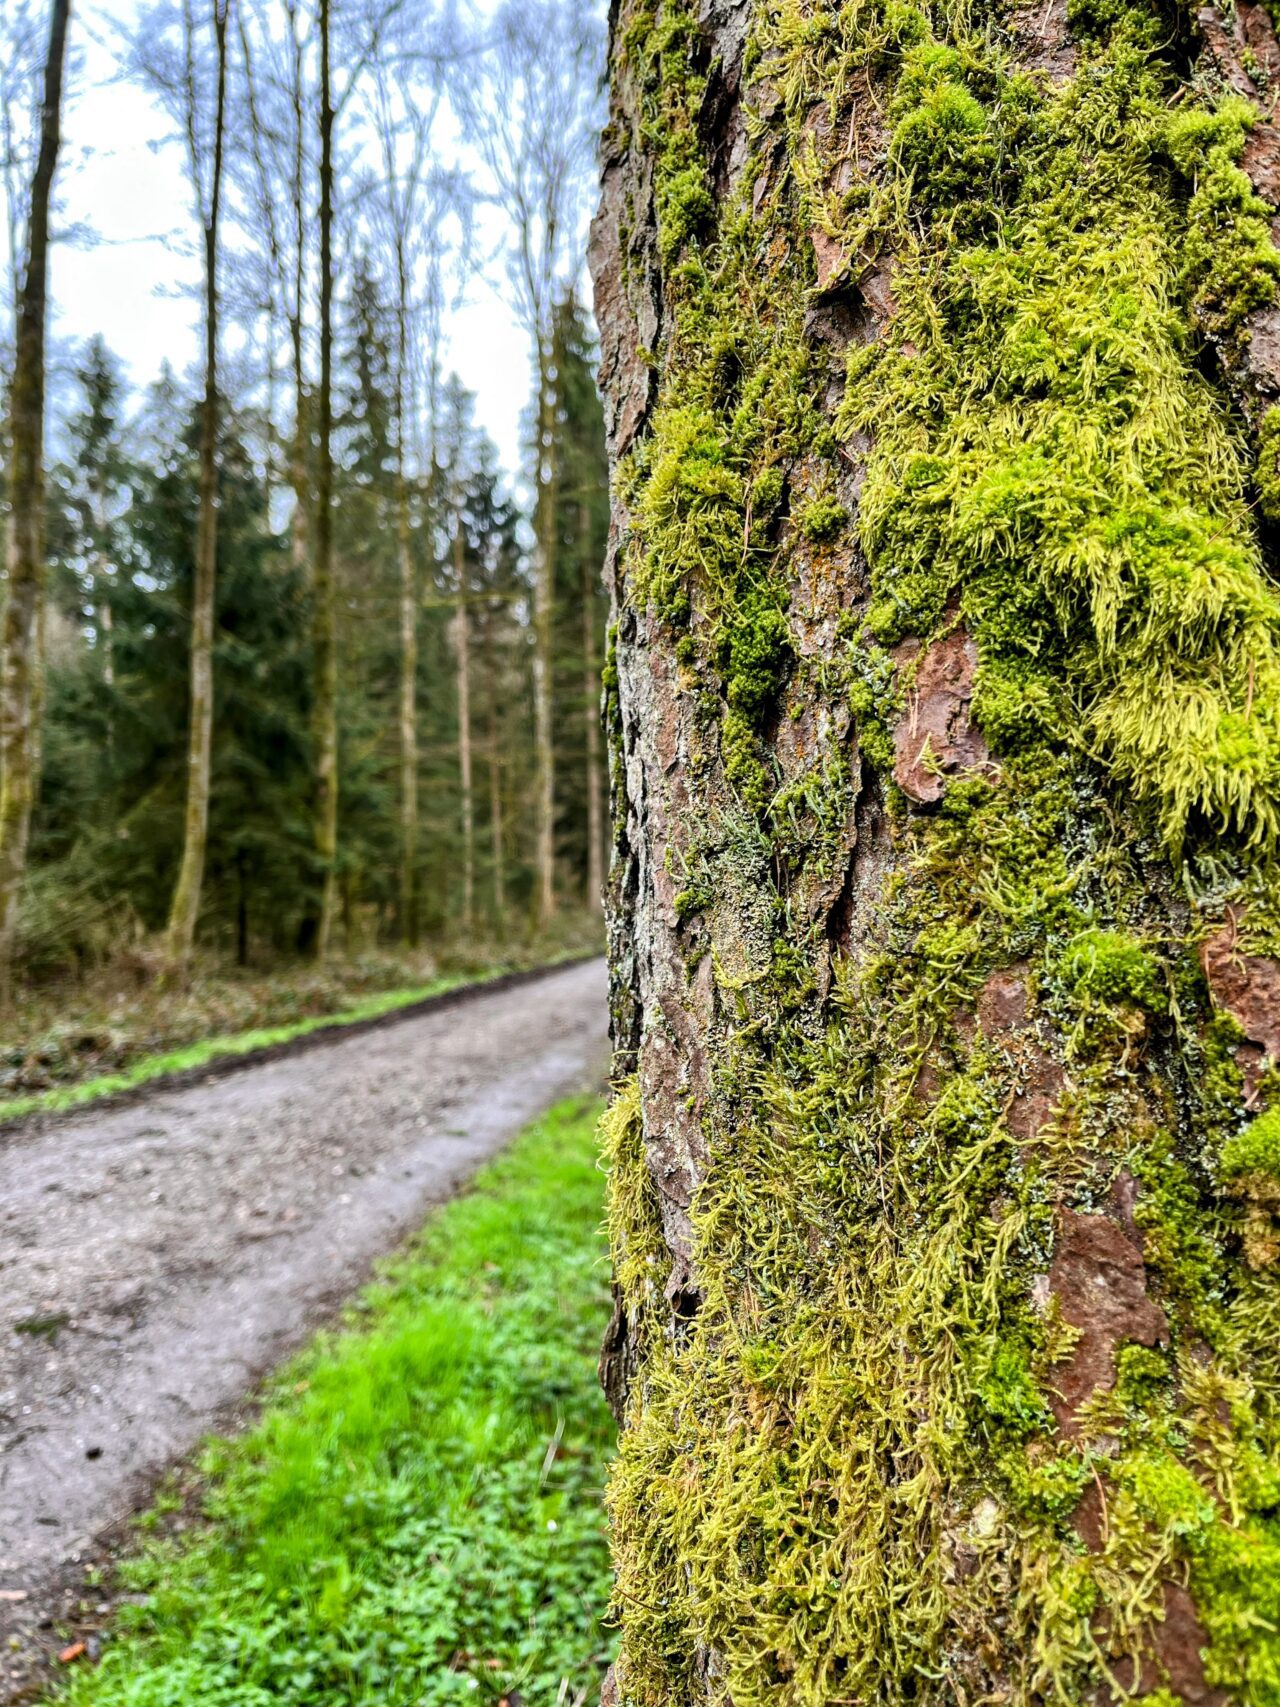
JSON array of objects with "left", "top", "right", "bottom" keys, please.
[{"left": 312, "top": 0, "right": 338, "bottom": 959}]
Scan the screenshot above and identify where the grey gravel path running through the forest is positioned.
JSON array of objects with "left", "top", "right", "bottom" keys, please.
[{"left": 0, "top": 961, "right": 608, "bottom": 1698}]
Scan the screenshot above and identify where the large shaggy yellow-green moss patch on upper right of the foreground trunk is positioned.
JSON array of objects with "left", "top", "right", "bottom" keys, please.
[{"left": 843, "top": 39, "right": 1280, "bottom": 843}]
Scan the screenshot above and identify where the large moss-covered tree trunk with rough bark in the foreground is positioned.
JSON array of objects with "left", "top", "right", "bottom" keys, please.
[{"left": 592, "top": 0, "right": 1280, "bottom": 1707}]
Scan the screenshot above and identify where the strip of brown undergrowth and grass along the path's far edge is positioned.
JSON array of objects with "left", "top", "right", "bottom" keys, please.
[{"left": 0, "top": 912, "right": 604, "bottom": 1120}]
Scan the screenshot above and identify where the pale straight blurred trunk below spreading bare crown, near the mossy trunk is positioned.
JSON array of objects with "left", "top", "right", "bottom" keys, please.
[{"left": 532, "top": 335, "right": 556, "bottom": 925}]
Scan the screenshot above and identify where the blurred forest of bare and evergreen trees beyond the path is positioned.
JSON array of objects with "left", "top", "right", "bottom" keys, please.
[{"left": 0, "top": 0, "right": 608, "bottom": 1044}]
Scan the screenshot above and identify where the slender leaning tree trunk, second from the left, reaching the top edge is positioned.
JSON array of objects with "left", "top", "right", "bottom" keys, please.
[{"left": 166, "top": 0, "right": 229, "bottom": 968}]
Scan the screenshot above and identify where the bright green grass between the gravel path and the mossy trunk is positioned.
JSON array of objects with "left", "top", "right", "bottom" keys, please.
[{"left": 61, "top": 1099, "right": 613, "bottom": 1707}]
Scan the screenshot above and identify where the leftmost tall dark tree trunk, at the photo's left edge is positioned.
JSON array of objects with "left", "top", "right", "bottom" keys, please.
[{"left": 0, "top": 0, "right": 72, "bottom": 1007}]
